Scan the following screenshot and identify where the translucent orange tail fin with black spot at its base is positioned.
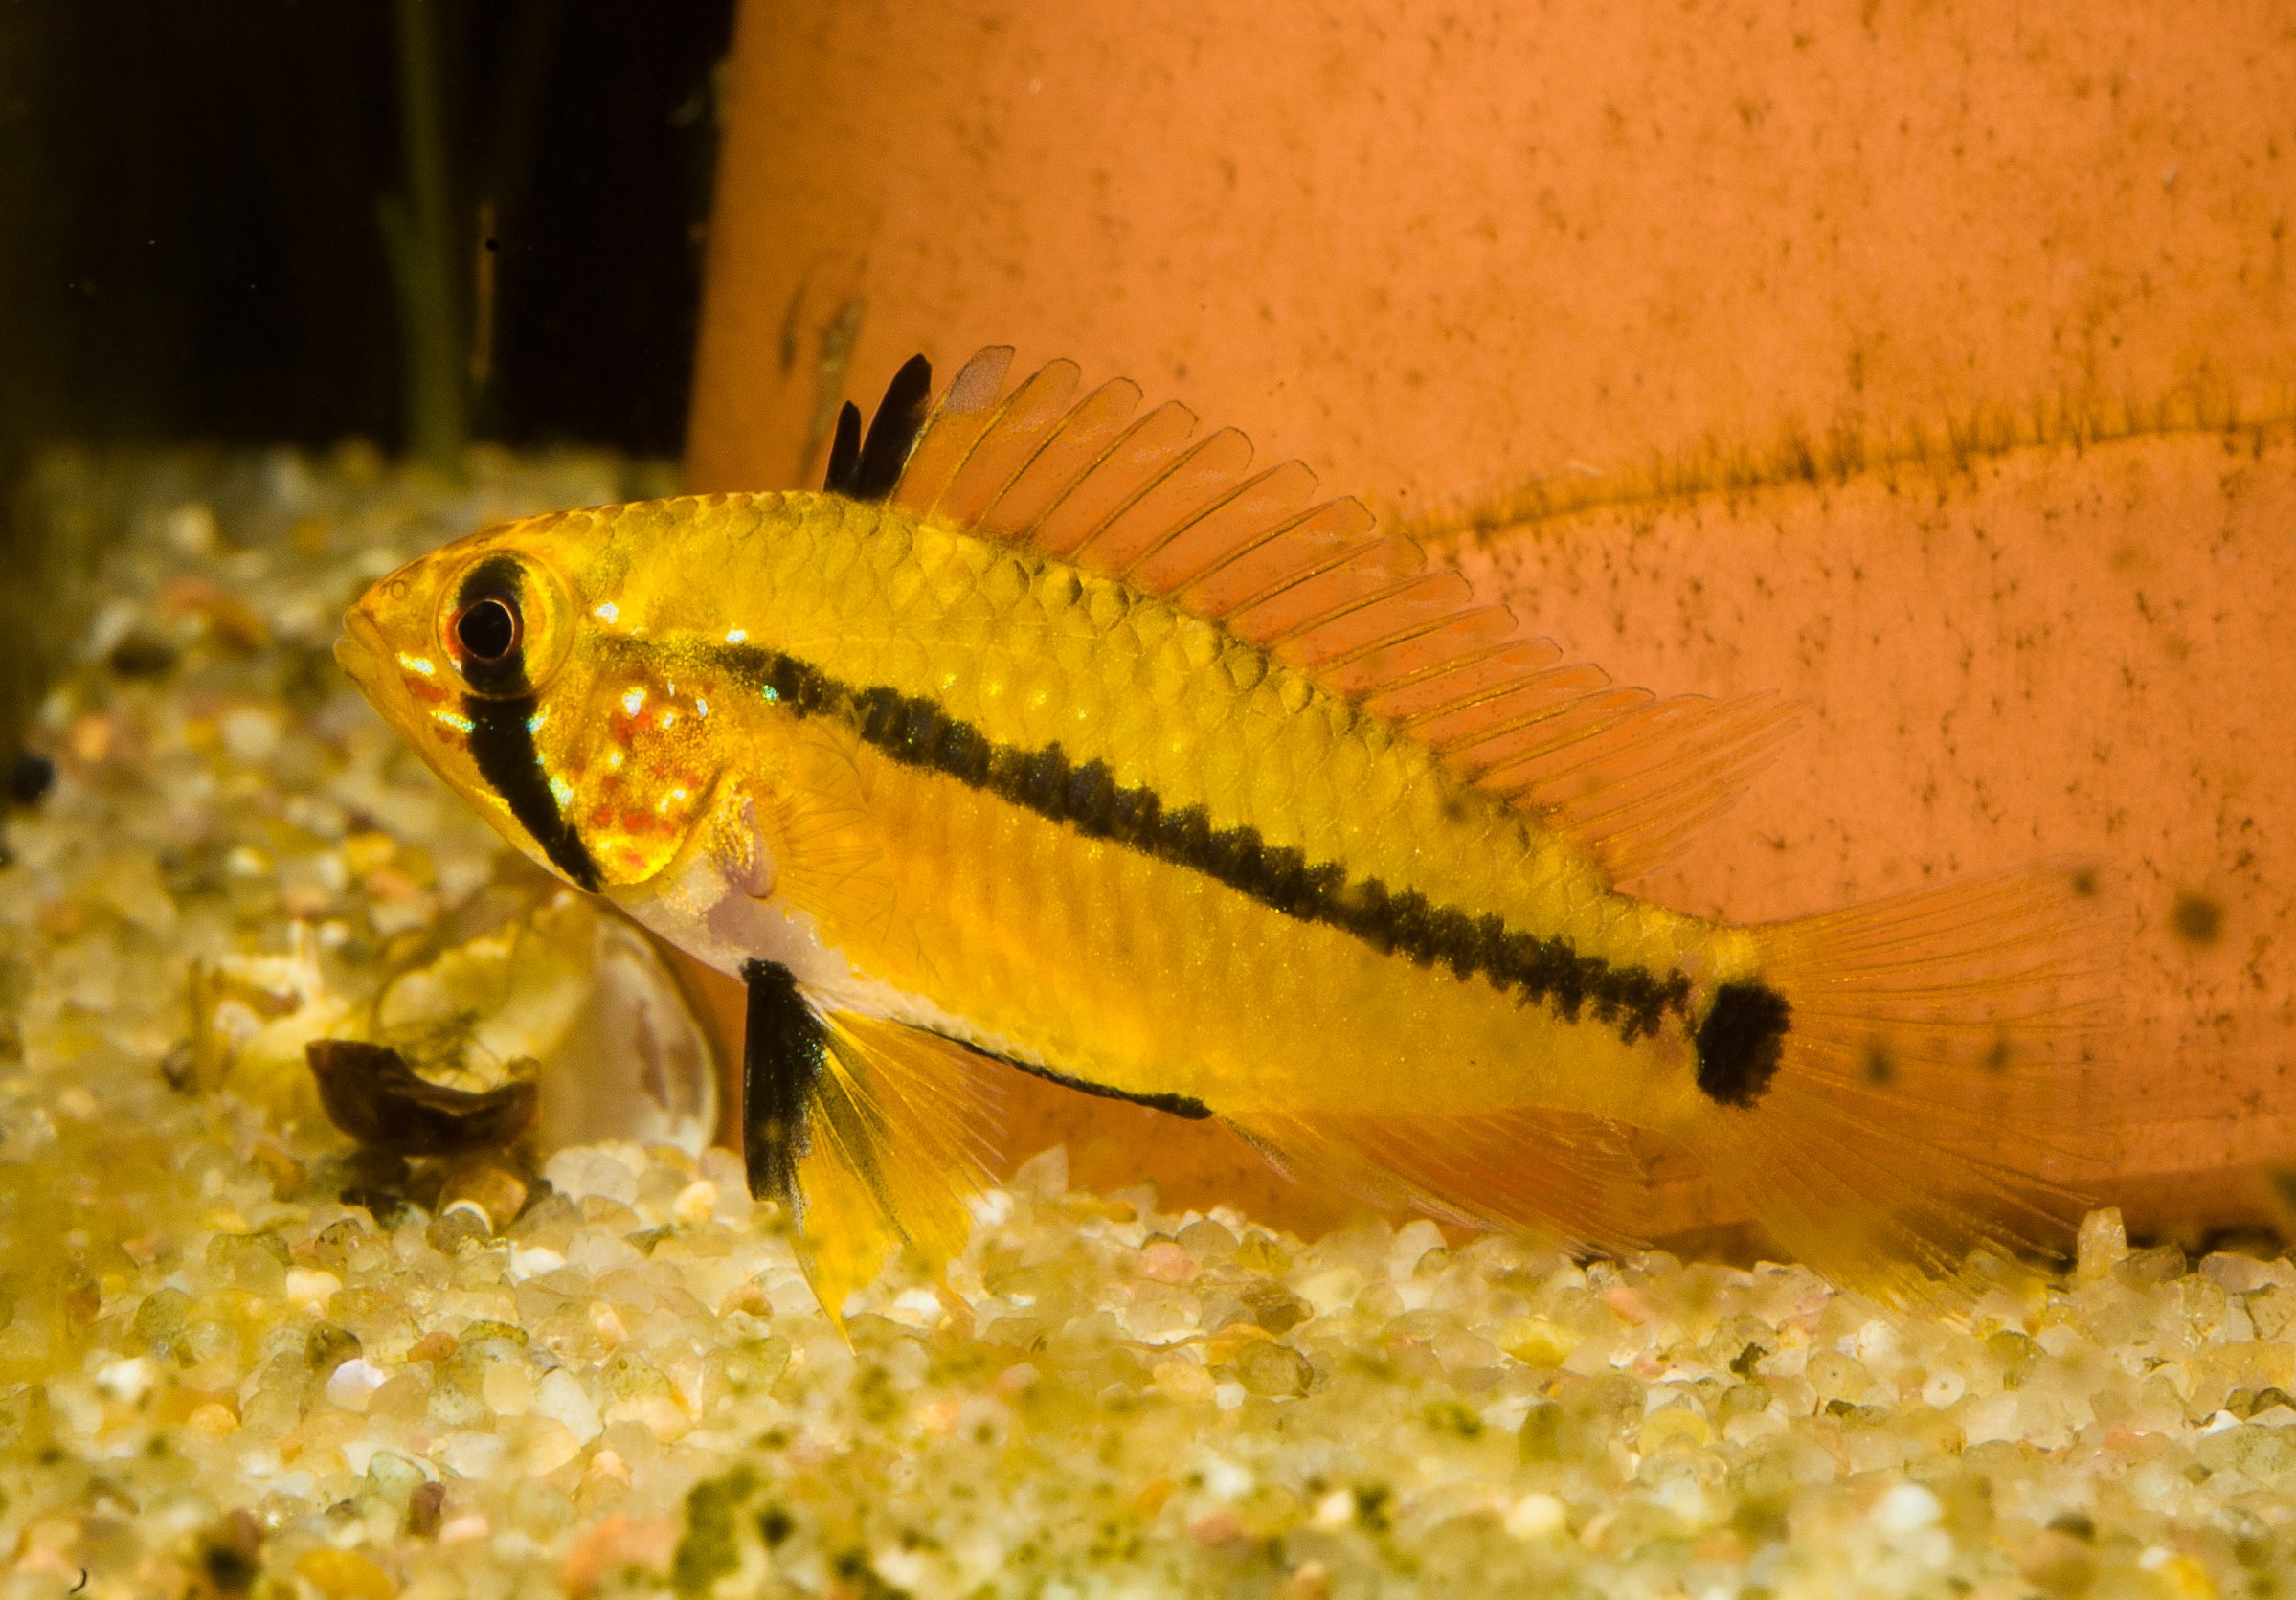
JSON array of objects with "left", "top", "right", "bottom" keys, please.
[{"left": 1685, "top": 866, "right": 2115, "bottom": 1299}]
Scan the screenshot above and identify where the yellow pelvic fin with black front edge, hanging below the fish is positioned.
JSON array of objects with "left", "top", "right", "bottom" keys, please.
[{"left": 742, "top": 962, "right": 999, "bottom": 1327}]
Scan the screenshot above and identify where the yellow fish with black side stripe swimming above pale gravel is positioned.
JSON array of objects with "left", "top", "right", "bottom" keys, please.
[{"left": 338, "top": 347, "right": 2096, "bottom": 1316}]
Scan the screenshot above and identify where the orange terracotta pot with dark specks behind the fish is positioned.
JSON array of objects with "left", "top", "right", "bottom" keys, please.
[{"left": 688, "top": 0, "right": 2296, "bottom": 1224}]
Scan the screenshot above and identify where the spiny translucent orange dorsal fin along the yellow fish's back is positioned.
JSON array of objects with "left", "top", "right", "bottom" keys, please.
[{"left": 867, "top": 345, "right": 1790, "bottom": 879}]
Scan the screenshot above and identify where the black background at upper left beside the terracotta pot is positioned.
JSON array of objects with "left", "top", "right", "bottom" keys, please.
[{"left": 0, "top": 0, "right": 732, "bottom": 470}]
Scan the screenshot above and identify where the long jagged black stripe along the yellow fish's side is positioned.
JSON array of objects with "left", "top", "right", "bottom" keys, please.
[{"left": 714, "top": 645, "right": 1690, "bottom": 1045}]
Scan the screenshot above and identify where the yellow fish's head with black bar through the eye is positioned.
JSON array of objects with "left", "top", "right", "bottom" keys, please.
[{"left": 335, "top": 507, "right": 723, "bottom": 890}]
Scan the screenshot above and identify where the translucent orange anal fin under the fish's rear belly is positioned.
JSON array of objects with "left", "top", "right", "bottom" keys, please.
[{"left": 1228, "top": 1107, "right": 1646, "bottom": 1251}]
